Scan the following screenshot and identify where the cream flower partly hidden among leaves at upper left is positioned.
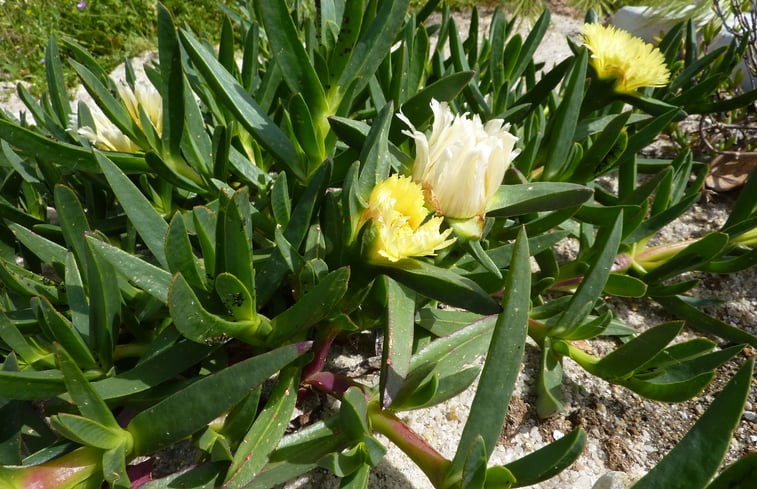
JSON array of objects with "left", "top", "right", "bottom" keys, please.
[{"left": 77, "top": 82, "right": 163, "bottom": 153}]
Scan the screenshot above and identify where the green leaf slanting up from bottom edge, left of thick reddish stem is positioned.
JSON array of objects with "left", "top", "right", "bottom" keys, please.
[{"left": 223, "top": 368, "right": 299, "bottom": 489}]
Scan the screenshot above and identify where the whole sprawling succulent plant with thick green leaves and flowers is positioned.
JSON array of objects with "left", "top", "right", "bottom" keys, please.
[{"left": 0, "top": 0, "right": 757, "bottom": 489}]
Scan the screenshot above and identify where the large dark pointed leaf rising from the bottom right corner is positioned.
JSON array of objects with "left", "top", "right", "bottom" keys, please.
[{"left": 632, "top": 359, "right": 754, "bottom": 489}]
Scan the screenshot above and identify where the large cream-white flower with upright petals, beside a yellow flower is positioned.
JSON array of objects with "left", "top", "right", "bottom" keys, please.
[{"left": 400, "top": 100, "right": 518, "bottom": 219}]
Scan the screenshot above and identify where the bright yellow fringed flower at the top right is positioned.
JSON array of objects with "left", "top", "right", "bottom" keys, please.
[{"left": 581, "top": 23, "right": 670, "bottom": 93}]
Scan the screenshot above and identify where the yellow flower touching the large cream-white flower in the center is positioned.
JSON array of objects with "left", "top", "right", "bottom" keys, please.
[{"left": 362, "top": 175, "right": 455, "bottom": 263}]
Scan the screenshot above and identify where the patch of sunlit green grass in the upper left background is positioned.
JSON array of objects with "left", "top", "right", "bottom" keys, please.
[{"left": 0, "top": 0, "right": 228, "bottom": 92}]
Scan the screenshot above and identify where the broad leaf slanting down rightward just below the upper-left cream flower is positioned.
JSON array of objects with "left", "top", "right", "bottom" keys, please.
[{"left": 94, "top": 151, "right": 168, "bottom": 268}]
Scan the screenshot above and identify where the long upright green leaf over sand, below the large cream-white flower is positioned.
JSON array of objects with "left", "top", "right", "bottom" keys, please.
[{"left": 453, "top": 229, "right": 531, "bottom": 468}]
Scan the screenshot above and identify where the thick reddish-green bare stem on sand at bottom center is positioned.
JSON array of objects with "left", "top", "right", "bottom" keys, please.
[{"left": 368, "top": 402, "right": 450, "bottom": 487}]
